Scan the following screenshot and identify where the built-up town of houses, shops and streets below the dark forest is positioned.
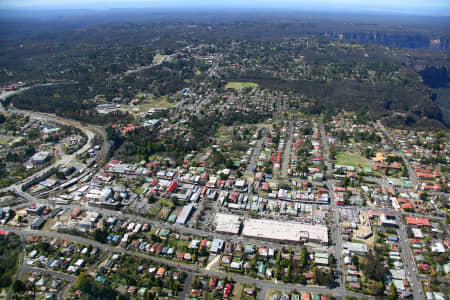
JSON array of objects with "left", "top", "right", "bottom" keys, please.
[{"left": 0, "top": 74, "right": 450, "bottom": 300}]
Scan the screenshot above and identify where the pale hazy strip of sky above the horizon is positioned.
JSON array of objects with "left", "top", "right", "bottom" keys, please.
[{"left": 0, "top": 0, "right": 450, "bottom": 16}]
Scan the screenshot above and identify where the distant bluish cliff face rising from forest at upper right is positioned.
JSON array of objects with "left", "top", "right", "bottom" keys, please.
[{"left": 321, "top": 31, "right": 450, "bottom": 51}]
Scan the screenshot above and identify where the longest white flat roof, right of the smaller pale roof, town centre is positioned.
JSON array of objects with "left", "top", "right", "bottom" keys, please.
[{"left": 242, "top": 219, "right": 328, "bottom": 243}]
